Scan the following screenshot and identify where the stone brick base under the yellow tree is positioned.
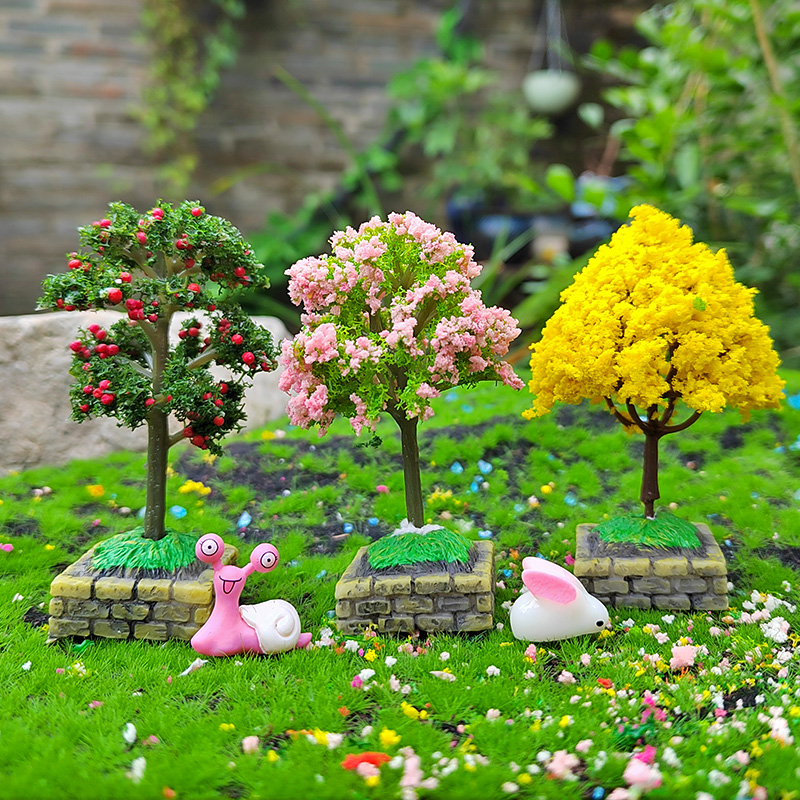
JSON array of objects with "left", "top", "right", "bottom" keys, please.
[{"left": 573, "top": 523, "right": 728, "bottom": 611}]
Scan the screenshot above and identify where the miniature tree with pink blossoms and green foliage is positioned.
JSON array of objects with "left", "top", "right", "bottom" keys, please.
[{"left": 280, "top": 211, "right": 524, "bottom": 527}]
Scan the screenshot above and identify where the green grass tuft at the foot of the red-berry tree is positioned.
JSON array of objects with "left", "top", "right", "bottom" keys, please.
[{"left": 92, "top": 527, "right": 197, "bottom": 572}]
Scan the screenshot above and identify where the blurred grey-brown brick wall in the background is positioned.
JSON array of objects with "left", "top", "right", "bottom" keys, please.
[{"left": 0, "top": 0, "right": 650, "bottom": 315}]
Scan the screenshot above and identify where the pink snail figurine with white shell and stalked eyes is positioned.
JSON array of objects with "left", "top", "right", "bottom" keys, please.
[{"left": 192, "top": 533, "right": 311, "bottom": 656}]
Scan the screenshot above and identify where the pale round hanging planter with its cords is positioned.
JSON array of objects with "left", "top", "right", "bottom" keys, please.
[{"left": 522, "top": 0, "right": 581, "bottom": 116}]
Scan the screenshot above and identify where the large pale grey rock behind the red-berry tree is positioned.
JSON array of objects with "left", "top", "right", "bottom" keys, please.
[{"left": 0, "top": 310, "right": 288, "bottom": 474}]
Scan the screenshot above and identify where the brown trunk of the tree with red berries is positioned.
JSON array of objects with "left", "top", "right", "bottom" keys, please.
[{"left": 144, "top": 315, "right": 171, "bottom": 540}]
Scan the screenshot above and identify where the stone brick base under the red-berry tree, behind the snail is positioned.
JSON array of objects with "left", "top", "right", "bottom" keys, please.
[{"left": 48, "top": 545, "right": 239, "bottom": 641}]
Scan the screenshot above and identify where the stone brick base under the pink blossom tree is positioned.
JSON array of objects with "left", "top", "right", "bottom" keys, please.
[{"left": 336, "top": 541, "right": 494, "bottom": 634}]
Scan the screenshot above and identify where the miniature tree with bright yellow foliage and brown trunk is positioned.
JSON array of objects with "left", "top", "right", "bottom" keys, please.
[{"left": 525, "top": 205, "right": 784, "bottom": 540}]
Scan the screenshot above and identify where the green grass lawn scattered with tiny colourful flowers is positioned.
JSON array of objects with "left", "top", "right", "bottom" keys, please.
[{"left": 0, "top": 373, "right": 800, "bottom": 800}]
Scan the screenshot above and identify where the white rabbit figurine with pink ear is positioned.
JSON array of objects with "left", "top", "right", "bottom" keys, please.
[{"left": 511, "top": 558, "right": 610, "bottom": 642}]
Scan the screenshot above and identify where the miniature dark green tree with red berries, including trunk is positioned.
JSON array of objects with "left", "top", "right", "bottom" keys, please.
[{"left": 39, "top": 201, "right": 277, "bottom": 556}]
